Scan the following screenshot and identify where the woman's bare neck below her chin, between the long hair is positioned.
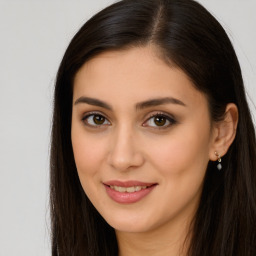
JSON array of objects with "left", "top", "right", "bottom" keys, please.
[{"left": 116, "top": 214, "right": 191, "bottom": 256}]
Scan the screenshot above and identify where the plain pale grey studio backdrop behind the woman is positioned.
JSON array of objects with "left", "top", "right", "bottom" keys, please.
[{"left": 0, "top": 0, "right": 256, "bottom": 256}]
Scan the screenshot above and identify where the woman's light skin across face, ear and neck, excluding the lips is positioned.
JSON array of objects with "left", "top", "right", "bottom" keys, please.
[{"left": 71, "top": 46, "right": 238, "bottom": 256}]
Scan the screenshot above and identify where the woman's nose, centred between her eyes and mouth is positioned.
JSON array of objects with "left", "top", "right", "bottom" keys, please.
[{"left": 108, "top": 124, "right": 144, "bottom": 171}]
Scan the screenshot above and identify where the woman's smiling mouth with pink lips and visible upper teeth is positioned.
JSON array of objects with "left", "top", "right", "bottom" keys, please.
[{"left": 103, "top": 181, "right": 157, "bottom": 204}]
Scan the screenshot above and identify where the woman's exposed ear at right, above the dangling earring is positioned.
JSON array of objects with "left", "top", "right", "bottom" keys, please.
[{"left": 209, "top": 103, "right": 238, "bottom": 161}]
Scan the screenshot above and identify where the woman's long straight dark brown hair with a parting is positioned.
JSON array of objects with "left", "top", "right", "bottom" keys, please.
[{"left": 50, "top": 0, "right": 256, "bottom": 256}]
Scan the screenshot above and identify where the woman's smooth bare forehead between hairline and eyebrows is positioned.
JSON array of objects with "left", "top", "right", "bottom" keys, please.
[{"left": 74, "top": 46, "right": 206, "bottom": 109}]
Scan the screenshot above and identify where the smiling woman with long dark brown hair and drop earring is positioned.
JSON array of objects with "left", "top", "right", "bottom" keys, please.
[{"left": 51, "top": 0, "right": 256, "bottom": 256}]
